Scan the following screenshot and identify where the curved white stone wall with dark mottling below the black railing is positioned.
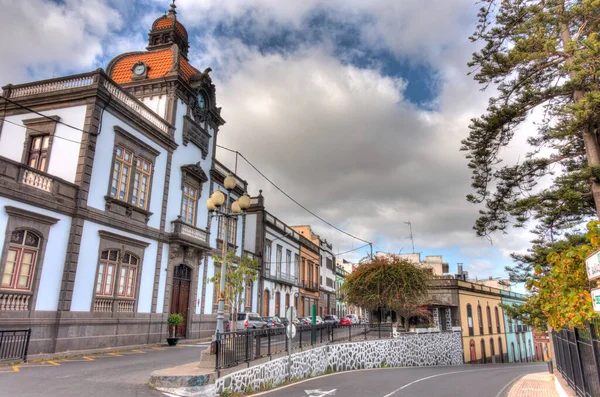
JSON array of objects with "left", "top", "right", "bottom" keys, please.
[{"left": 215, "top": 332, "right": 463, "bottom": 393}]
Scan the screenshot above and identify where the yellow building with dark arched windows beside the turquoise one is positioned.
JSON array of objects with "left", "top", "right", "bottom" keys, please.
[{"left": 456, "top": 280, "right": 507, "bottom": 363}]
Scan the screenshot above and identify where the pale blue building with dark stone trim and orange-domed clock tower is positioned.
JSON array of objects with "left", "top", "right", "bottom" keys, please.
[{"left": 0, "top": 5, "right": 251, "bottom": 353}]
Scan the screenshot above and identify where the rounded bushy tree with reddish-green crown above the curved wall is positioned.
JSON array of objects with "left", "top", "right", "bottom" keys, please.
[{"left": 342, "top": 255, "right": 431, "bottom": 324}]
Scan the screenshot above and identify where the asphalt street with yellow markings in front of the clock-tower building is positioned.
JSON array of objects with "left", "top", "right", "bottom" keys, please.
[{"left": 0, "top": 344, "right": 207, "bottom": 397}]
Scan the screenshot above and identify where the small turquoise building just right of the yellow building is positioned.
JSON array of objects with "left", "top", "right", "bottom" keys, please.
[{"left": 502, "top": 290, "right": 535, "bottom": 363}]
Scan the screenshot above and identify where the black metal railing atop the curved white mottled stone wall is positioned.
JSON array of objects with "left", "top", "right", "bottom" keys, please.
[{"left": 215, "top": 323, "right": 393, "bottom": 371}]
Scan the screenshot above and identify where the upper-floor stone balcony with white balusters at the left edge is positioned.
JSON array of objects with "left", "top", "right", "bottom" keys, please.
[{"left": 0, "top": 157, "right": 79, "bottom": 210}]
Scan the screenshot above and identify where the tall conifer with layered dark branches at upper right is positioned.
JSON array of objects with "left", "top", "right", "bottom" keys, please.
[{"left": 461, "top": 0, "right": 600, "bottom": 242}]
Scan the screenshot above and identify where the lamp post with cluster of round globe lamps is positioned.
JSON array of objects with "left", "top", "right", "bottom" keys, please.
[{"left": 206, "top": 174, "right": 250, "bottom": 339}]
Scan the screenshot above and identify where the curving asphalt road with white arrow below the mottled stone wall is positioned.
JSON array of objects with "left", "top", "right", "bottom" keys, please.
[{"left": 259, "top": 364, "right": 548, "bottom": 397}]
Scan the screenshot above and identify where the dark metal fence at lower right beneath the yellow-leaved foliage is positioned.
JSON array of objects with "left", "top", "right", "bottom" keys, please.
[{"left": 552, "top": 322, "right": 600, "bottom": 397}]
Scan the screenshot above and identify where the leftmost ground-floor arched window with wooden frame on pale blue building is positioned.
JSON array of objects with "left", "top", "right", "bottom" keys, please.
[{"left": 1, "top": 230, "right": 41, "bottom": 291}]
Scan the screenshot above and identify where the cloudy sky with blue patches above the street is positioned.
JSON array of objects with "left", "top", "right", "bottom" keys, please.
[{"left": 0, "top": 0, "right": 530, "bottom": 284}]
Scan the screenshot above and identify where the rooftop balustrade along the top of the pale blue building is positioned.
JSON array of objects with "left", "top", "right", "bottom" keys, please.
[{"left": 2, "top": 70, "right": 173, "bottom": 136}]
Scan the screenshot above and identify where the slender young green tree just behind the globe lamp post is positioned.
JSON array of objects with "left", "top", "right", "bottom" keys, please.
[{"left": 209, "top": 251, "right": 258, "bottom": 332}]
